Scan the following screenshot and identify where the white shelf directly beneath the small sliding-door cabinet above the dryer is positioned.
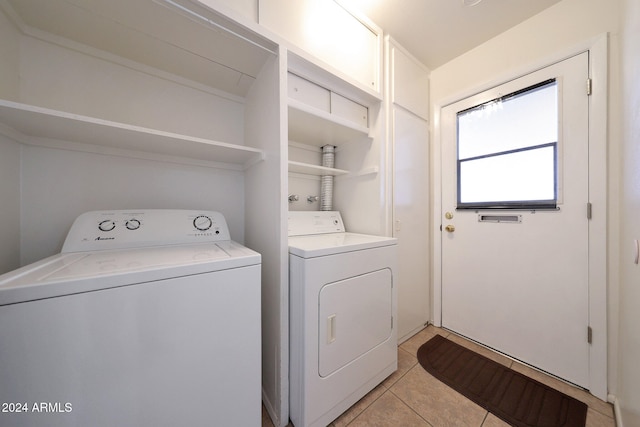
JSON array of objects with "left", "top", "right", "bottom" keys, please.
[{"left": 288, "top": 99, "right": 369, "bottom": 147}]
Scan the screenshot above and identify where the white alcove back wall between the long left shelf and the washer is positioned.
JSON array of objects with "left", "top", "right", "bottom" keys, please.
[{"left": 20, "top": 146, "right": 244, "bottom": 265}]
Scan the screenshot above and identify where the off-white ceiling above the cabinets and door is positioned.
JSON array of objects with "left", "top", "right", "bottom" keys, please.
[{"left": 339, "top": 0, "right": 561, "bottom": 70}]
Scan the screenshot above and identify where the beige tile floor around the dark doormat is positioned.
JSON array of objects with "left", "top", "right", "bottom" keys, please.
[{"left": 262, "top": 326, "right": 615, "bottom": 427}]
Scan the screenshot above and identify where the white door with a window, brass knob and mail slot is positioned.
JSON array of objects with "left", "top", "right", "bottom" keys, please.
[{"left": 440, "top": 53, "right": 589, "bottom": 388}]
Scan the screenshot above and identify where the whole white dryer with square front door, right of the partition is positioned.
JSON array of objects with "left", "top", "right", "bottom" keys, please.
[{"left": 289, "top": 212, "right": 398, "bottom": 427}]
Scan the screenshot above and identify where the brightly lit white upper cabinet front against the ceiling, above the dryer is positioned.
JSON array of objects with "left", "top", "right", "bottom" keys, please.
[{"left": 259, "top": 0, "right": 382, "bottom": 92}]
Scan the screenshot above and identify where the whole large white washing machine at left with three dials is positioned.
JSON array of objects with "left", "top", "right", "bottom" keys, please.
[{"left": 0, "top": 210, "right": 261, "bottom": 427}]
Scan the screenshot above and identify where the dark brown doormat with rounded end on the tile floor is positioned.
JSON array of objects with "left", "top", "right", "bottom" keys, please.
[{"left": 418, "top": 335, "right": 587, "bottom": 427}]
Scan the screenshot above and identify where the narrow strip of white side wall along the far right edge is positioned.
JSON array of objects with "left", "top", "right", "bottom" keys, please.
[{"left": 612, "top": 0, "right": 640, "bottom": 427}]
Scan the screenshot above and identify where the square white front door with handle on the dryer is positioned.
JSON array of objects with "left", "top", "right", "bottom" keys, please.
[{"left": 318, "top": 268, "right": 393, "bottom": 377}]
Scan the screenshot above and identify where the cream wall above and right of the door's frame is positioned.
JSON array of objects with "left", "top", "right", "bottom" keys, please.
[{"left": 431, "top": 0, "right": 620, "bottom": 398}]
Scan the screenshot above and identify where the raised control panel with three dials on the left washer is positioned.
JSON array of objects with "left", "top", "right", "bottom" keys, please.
[{"left": 62, "top": 209, "right": 231, "bottom": 253}]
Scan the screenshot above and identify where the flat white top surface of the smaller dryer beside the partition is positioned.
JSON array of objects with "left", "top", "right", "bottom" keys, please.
[{"left": 289, "top": 233, "right": 398, "bottom": 258}]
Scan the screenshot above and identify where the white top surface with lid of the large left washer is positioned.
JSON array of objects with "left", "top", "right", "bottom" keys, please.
[{"left": 0, "top": 241, "right": 261, "bottom": 306}]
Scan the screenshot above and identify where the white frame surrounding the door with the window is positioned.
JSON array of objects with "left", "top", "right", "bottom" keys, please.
[{"left": 432, "top": 34, "right": 609, "bottom": 401}]
